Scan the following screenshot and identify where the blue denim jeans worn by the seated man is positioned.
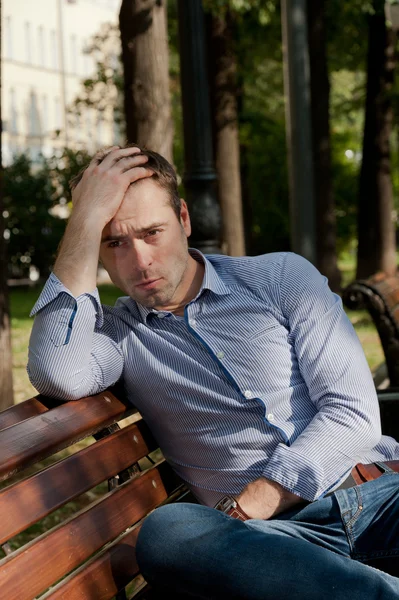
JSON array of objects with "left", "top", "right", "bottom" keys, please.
[{"left": 136, "top": 473, "right": 399, "bottom": 600}]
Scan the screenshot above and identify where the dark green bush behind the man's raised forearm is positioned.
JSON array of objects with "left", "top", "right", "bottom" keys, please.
[{"left": 3, "top": 149, "right": 88, "bottom": 277}]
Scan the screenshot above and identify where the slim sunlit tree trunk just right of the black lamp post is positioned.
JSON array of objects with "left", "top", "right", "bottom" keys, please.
[{"left": 206, "top": 10, "right": 245, "bottom": 256}]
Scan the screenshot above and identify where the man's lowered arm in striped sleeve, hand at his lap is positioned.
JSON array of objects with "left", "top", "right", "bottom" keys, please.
[{"left": 238, "top": 254, "right": 381, "bottom": 518}]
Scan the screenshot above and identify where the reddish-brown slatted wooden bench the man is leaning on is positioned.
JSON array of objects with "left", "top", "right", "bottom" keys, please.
[{"left": 0, "top": 390, "right": 190, "bottom": 600}]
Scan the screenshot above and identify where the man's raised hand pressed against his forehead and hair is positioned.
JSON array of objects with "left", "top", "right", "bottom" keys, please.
[{"left": 72, "top": 146, "right": 153, "bottom": 229}]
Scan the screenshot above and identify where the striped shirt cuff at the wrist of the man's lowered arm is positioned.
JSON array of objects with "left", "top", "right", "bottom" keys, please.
[{"left": 262, "top": 444, "right": 324, "bottom": 502}]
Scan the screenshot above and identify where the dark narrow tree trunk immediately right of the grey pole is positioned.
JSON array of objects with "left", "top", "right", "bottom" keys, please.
[{"left": 307, "top": 0, "right": 341, "bottom": 292}]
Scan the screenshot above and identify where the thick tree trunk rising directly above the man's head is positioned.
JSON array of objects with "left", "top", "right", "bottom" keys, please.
[{"left": 119, "top": 0, "right": 173, "bottom": 161}]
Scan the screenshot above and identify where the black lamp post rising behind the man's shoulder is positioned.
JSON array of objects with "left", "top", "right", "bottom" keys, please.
[{"left": 178, "top": 0, "right": 221, "bottom": 254}]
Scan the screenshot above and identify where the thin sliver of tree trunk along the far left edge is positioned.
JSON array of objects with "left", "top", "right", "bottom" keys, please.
[{"left": 0, "top": 1, "right": 14, "bottom": 410}]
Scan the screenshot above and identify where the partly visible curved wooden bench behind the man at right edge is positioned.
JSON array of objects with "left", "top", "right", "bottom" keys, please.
[{"left": 342, "top": 273, "right": 399, "bottom": 438}]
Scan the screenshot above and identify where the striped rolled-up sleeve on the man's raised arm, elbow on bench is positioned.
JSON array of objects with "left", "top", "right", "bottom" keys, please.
[{"left": 27, "top": 274, "right": 124, "bottom": 400}]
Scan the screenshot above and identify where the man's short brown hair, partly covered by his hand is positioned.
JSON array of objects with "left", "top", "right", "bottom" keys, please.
[{"left": 69, "top": 144, "right": 181, "bottom": 221}]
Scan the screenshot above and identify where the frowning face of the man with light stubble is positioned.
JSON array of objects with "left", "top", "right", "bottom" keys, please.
[{"left": 100, "top": 179, "right": 191, "bottom": 310}]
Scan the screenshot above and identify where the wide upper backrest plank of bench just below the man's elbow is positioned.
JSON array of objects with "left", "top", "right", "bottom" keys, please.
[{"left": 0, "top": 391, "right": 135, "bottom": 481}]
